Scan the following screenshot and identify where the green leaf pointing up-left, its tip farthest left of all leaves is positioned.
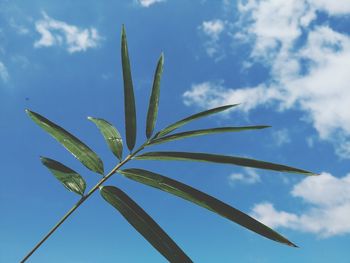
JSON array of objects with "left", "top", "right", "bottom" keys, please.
[{"left": 26, "top": 110, "right": 104, "bottom": 175}]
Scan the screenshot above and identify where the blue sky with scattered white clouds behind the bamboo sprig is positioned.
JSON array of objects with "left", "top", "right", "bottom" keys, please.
[{"left": 0, "top": 0, "right": 350, "bottom": 263}]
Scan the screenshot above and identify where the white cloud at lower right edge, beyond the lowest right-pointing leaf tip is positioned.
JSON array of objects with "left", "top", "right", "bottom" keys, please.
[{"left": 252, "top": 173, "right": 350, "bottom": 238}]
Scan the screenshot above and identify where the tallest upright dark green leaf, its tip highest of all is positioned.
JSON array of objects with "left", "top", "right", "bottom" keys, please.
[{"left": 121, "top": 25, "right": 136, "bottom": 151}]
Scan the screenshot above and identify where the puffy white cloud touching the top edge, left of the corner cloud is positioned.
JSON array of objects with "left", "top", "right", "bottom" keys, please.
[{"left": 238, "top": 0, "right": 314, "bottom": 57}]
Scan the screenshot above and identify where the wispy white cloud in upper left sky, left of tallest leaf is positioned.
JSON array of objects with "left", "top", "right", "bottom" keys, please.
[{"left": 34, "top": 13, "right": 101, "bottom": 53}]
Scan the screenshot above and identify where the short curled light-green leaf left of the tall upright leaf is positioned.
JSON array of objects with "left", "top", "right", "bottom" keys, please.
[{"left": 88, "top": 117, "right": 123, "bottom": 160}]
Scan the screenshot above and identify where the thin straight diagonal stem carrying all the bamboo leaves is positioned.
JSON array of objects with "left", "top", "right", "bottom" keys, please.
[{"left": 20, "top": 141, "right": 148, "bottom": 263}]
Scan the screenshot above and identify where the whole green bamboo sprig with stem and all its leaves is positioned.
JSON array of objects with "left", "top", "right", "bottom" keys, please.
[{"left": 21, "top": 26, "right": 315, "bottom": 262}]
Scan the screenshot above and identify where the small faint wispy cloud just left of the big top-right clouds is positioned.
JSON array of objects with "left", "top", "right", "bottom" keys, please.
[{"left": 199, "top": 19, "right": 226, "bottom": 58}]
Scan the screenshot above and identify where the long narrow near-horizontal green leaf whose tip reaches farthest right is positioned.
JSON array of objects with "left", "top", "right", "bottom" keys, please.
[{"left": 134, "top": 152, "right": 315, "bottom": 175}]
